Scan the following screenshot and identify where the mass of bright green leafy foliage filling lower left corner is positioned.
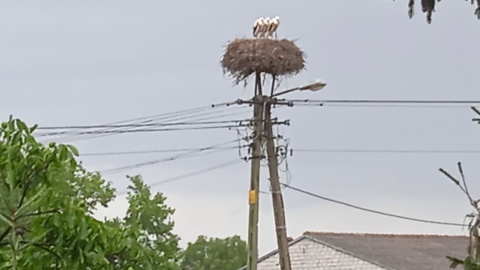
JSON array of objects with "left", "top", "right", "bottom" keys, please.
[{"left": 0, "top": 117, "right": 179, "bottom": 270}]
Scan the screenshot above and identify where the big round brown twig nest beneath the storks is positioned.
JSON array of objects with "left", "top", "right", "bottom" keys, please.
[{"left": 221, "top": 39, "right": 305, "bottom": 83}]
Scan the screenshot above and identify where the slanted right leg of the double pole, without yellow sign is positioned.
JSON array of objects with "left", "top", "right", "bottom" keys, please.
[{"left": 265, "top": 100, "right": 291, "bottom": 270}]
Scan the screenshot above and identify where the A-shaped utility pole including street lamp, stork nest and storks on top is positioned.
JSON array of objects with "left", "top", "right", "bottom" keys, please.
[{"left": 221, "top": 22, "right": 326, "bottom": 270}]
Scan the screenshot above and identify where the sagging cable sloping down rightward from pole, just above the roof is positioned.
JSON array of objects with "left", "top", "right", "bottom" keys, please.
[{"left": 282, "top": 184, "right": 467, "bottom": 227}]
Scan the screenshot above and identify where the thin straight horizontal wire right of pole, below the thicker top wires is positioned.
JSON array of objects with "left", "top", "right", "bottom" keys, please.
[{"left": 292, "top": 148, "right": 480, "bottom": 154}]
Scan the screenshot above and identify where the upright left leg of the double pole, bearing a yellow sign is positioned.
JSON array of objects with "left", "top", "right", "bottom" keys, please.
[{"left": 247, "top": 73, "right": 264, "bottom": 270}]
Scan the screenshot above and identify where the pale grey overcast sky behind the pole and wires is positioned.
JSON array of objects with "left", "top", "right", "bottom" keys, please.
[{"left": 0, "top": 0, "right": 480, "bottom": 255}]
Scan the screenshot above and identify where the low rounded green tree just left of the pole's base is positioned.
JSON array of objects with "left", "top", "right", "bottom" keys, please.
[{"left": 181, "top": 235, "right": 247, "bottom": 270}]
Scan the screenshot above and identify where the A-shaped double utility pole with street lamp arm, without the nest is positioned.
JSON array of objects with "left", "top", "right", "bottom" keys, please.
[{"left": 246, "top": 80, "right": 326, "bottom": 270}]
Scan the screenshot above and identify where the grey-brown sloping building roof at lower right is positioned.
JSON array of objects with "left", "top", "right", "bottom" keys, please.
[{"left": 246, "top": 232, "right": 468, "bottom": 270}]
